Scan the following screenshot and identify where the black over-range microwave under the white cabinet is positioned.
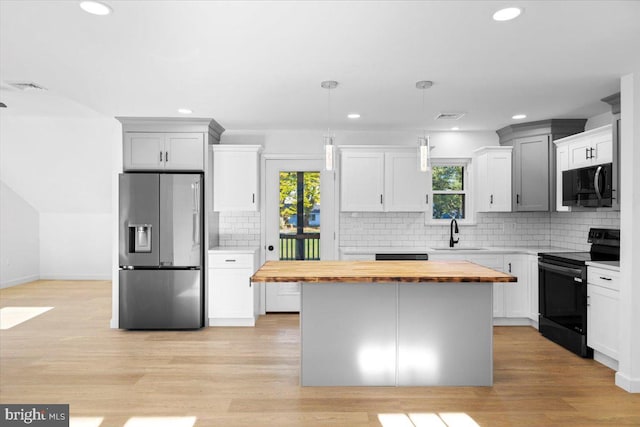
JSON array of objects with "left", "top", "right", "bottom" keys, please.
[{"left": 562, "top": 163, "right": 614, "bottom": 208}]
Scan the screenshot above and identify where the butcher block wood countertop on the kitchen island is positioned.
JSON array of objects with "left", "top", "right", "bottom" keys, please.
[{"left": 251, "top": 261, "right": 517, "bottom": 283}]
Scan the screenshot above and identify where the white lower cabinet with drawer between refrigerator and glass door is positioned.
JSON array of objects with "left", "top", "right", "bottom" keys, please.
[{"left": 207, "top": 249, "right": 260, "bottom": 326}]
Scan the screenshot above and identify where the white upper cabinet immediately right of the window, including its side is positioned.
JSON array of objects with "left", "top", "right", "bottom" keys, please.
[{"left": 473, "top": 147, "right": 512, "bottom": 212}]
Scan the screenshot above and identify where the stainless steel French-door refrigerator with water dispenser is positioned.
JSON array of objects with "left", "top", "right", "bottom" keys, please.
[{"left": 119, "top": 173, "right": 204, "bottom": 329}]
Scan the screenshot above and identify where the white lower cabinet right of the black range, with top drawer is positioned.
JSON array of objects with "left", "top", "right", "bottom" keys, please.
[{"left": 587, "top": 267, "right": 620, "bottom": 369}]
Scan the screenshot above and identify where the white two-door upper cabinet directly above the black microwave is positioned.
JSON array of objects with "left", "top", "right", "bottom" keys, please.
[{"left": 555, "top": 125, "right": 613, "bottom": 169}]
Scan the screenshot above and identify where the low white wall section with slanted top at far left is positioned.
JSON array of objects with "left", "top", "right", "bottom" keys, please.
[{"left": 0, "top": 181, "right": 40, "bottom": 288}]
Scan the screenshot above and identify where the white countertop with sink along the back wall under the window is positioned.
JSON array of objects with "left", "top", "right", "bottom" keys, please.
[{"left": 340, "top": 246, "right": 576, "bottom": 255}]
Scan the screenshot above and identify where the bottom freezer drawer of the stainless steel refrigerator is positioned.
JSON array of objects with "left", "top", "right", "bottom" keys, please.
[{"left": 120, "top": 270, "right": 204, "bottom": 329}]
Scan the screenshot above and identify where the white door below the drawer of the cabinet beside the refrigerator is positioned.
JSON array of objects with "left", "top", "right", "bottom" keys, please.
[{"left": 209, "top": 268, "right": 254, "bottom": 319}]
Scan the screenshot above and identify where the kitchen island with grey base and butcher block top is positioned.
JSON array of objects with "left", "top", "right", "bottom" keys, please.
[{"left": 251, "top": 261, "right": 516, "bottom": 386}]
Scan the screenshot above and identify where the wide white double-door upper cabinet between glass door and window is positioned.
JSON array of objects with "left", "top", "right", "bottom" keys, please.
[{"left": 340, "top": 147, "right": 429, "bottom": 212}]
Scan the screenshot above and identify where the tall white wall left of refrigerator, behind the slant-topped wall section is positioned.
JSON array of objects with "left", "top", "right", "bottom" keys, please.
[{"left": 0, "top": 109, "right": 122, "bottom": 279}]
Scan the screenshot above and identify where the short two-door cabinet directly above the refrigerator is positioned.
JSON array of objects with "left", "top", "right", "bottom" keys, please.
[{"left": 123, "top": 132, "right": 204, "bottom": 171}]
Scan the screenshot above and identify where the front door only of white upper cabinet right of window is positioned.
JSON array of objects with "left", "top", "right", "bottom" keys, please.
[{"left": 485, "top": 151, "right": 511, "bottom": 212}]
